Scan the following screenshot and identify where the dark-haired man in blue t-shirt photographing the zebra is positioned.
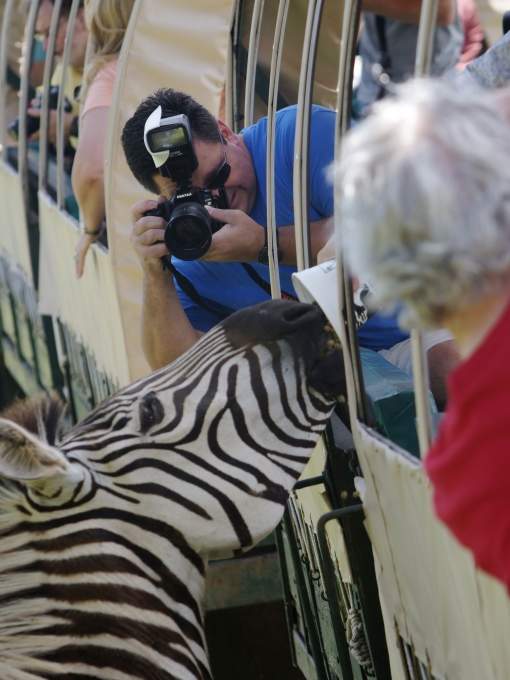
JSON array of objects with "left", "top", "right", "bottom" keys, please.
[{"left": 122, "top": 90, "right": 335, "bottom": 368}]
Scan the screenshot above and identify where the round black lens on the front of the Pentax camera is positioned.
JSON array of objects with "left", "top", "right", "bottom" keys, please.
[{"left": 165, "top": 201, "right": 212, "bottom": 260}]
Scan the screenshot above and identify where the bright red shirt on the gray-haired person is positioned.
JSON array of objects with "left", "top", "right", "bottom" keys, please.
[{"left": 425, "top": 305, "right": 510, "bottom": 589}]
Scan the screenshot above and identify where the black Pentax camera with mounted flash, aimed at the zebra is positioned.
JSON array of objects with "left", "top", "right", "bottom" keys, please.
[{"left": 144, "top": 106, "right": 230, "bottom": 260}]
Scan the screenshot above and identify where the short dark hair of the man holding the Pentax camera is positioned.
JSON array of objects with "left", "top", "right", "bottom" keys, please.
[{"left": 122, "top": 89, "right": 221, "bottom": 194}]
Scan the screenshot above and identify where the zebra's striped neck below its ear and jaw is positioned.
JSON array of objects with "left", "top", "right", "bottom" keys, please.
[{"left": 0, "top": 476, "right": 210, "bottom": 680}]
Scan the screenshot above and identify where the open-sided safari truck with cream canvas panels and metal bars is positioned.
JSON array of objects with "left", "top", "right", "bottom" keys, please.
[{"left": 0, "top": 0, "right": 510, "bottom": 680}]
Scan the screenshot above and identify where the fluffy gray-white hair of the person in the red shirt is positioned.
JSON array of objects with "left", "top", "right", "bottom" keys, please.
[{"left": 334, "top": 79, "right": 510, "bottom": 327}]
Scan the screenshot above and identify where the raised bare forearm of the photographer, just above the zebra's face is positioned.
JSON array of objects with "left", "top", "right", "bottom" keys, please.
[{"left": 142, "top": 270, "right": 202, "bottom": 369}]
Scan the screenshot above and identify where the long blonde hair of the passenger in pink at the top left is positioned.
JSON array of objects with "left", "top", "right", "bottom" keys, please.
[{"left": 80, "top": 0, "right": 135, "bottom": 102}]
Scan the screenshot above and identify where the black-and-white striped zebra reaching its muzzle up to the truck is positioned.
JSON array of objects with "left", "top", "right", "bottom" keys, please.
[{"left": 0, "top": 301, "right": 343, "bottom": 680}]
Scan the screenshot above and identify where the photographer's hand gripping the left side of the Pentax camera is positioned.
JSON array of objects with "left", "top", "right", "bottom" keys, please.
[{"left": 131, "top": 196, "right": 169, "bottom": 271}]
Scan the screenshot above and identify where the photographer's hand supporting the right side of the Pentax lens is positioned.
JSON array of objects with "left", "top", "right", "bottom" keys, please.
[{"left": 202, "top": 207, "right": 265, "bottom": 262}]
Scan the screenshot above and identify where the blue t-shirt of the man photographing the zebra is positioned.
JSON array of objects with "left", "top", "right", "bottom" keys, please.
[{"left": 172, "top": 106, "right": 407, "bottom": 349}]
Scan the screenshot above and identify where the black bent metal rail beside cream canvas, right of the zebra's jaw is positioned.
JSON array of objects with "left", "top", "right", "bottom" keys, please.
[{"left": 317, "top": 504, "right": 363, "bottom": 680}]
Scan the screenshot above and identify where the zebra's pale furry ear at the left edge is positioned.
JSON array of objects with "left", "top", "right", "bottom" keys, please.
[{"left": 0, "top": 418, "right": 69, "bottom": 482}]
